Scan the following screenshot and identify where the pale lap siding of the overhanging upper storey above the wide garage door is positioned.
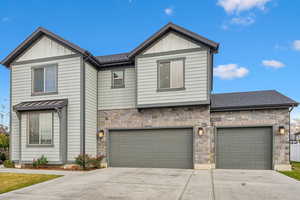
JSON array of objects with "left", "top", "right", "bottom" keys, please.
[{"left": 137, "top": 50, "right": 208, "bottom": 105}]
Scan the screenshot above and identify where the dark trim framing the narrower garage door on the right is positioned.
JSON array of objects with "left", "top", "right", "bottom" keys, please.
[{"left": 214, "top": 124, "right": 276, "bottom": 170}]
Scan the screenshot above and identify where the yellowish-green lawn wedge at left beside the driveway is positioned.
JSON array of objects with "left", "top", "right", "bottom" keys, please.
[{"left": 0, "top": 173, "right": 61, "bottom": 194}]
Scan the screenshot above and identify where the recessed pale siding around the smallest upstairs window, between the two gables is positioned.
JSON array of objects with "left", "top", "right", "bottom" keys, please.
[{"left": 98, "top": 67, "right": 136, "bottom": 110}]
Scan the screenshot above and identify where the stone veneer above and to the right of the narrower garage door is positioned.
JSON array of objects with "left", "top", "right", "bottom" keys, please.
[{"left": 211, "top": 109, "right": 290, "bottom": 170}]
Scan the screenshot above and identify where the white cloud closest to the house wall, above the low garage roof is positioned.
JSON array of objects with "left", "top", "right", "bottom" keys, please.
[{"left": 214, "top": 64, "right": 249, "bottom": 80}]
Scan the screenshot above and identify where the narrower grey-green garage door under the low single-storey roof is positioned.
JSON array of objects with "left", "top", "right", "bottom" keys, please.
[{"left": 216, "top": 127, "right": 272, "bottom": 169}]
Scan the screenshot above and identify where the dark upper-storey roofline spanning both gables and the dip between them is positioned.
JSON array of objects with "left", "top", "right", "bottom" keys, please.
[{"left": 1, "top": 22, "right": 219, "bottom": 67}]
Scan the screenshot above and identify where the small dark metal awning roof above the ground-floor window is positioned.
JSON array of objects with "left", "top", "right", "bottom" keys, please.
[{"left": 14, "top": 99, "right": 68, "bottom": 112}]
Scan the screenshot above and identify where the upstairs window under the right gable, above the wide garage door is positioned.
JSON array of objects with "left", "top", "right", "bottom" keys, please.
[{"left": 158, "top": 58, "right": 184, "bottom": 91}]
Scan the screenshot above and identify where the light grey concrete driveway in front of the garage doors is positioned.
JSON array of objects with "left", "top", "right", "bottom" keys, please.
[{"left": 0, "top": 168, "right": 300, "bottom": 200}]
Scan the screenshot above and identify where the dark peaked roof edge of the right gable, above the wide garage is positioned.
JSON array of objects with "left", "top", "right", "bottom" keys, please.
[{"left": 128, "top": 22, "right": 219, "bottom": 58}]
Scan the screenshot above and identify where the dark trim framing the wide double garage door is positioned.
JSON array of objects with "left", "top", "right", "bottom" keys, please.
[{"left": 104, "top": 126, "right": 195, "bottom": 167}]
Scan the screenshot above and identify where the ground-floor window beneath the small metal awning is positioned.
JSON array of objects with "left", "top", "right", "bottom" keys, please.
[{"left": 28, "top": 112, "right": 53, "bottom": 145}]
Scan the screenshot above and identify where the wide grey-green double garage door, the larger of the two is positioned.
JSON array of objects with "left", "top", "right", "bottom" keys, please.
[{"left": 109, "top": 129, "right": 193, "bottom": 169}]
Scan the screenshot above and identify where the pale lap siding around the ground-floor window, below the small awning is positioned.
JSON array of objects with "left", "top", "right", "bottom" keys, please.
[{"left": 21, "top": 113, "right": 60, "bottom": 162}]
